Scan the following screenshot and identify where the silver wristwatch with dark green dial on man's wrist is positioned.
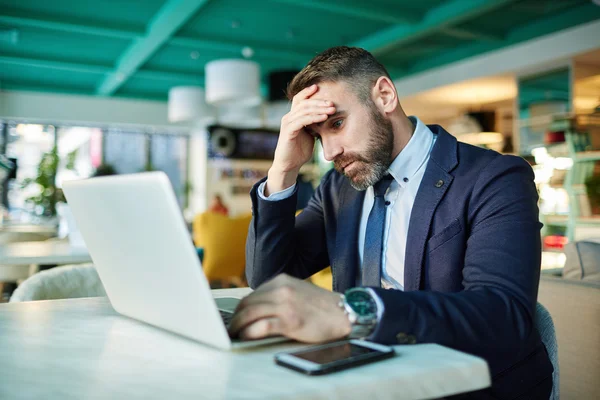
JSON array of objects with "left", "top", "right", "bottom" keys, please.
[{"left": 339, "top": 288, "right": 382, "bottom": 339}]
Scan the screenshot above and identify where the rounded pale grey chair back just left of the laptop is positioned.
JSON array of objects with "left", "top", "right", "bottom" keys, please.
[{"left": 10, "top": 264, "right": 106, "bottom": 303}]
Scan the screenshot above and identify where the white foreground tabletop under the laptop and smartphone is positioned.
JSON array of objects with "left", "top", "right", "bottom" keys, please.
[{"left": 0, "top": 289, "right": 490, "bottom": 400}]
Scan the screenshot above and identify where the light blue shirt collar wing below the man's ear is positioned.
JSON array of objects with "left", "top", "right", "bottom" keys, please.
[{"left": 388, "top": 117, "right": 433, "bottom": 186}]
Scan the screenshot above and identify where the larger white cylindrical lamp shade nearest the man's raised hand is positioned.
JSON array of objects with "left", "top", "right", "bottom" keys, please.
[{"left": 205, "top": 59, "right": 261, "bottom": 107}]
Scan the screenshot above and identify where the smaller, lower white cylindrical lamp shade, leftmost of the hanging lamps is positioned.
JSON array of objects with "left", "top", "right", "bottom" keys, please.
[{"left": 169, "top": 86, "right": 214, "bottom": 122}]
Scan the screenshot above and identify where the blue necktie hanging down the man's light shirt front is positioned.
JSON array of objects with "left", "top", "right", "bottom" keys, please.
[{"left": 362, "top": 174, "right": 394, "bottom": 287}]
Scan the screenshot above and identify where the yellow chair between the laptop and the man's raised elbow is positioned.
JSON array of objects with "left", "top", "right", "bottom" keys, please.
[{"left": 192, "top": 212, "right": 252, "bottom": 287}]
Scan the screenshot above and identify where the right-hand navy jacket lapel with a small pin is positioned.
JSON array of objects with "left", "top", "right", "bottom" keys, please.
[{"left": 404, "top": 125, "right": 458, "bottom": 291}]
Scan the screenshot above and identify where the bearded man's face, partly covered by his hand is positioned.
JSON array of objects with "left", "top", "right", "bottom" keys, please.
[{"left": 307, "top": 82, "right": 394, "bottom": 190}]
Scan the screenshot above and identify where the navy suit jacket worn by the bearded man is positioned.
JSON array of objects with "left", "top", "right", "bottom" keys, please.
[{"left": 246, "top": 125, "right": 552, "bottom": 399}]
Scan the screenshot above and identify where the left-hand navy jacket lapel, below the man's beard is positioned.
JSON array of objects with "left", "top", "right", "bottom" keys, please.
[{"left": 331, "top": 182, "right": 365, "bottom": 292}]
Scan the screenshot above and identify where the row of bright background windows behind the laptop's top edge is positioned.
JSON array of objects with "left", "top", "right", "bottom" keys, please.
[{"left": 0, "top": 123, "right": 189, "bottom": 222}]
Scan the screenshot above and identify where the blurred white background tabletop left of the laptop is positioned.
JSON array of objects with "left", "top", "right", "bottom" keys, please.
[{"left": 0, "top": 240, "right": 92, "bottom": 268}]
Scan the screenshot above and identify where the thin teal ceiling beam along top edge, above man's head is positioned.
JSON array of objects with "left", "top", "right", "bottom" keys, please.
[{"left": 272, "top": 0, "right": 422, "bottom": 24}]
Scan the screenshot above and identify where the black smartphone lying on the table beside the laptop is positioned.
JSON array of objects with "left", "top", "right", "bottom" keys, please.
[{"left": 275, "top": 340, "right": 395, "bottom": 375}]
